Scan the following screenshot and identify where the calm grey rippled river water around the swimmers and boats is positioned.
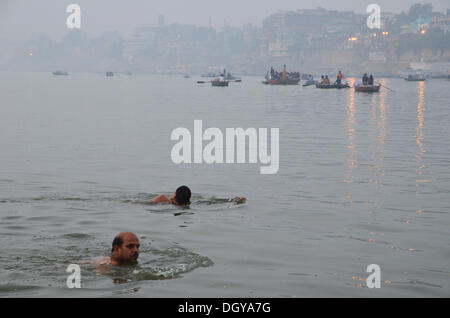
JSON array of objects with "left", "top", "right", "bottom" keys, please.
[{"left": 0, "top": 73, "right": 450, "bottom": 297}]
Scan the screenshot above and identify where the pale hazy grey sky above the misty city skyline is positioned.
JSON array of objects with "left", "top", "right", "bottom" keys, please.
[{"left": 0, "top": 0, "right": 450, "bottom": 40}]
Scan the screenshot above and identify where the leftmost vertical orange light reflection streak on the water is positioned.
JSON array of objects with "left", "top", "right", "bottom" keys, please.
[{"left": 344, "top": 78, "right": 358, "bottom": 183}]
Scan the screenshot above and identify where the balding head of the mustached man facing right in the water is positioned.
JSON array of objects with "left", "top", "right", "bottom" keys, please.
[{"left": 111, "top": 232, "right": 140, "bottom": 266}]
